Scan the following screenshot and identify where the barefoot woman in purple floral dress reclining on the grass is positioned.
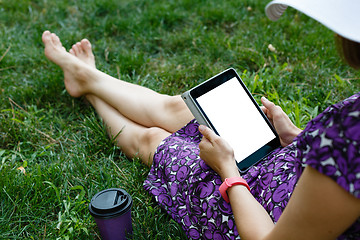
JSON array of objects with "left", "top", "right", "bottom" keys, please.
[{"left": 42, "top": 0, "right": 360, "bottom": 239}]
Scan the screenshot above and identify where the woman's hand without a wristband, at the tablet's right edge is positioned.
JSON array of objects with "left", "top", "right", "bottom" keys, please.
[{"left": 261, "top": 97, "right": 302, "bottom": 147}]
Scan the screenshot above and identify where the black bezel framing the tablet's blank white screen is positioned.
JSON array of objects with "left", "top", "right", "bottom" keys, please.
[{"left": 189, "top": 68, "right": 280, "bottom": 172}]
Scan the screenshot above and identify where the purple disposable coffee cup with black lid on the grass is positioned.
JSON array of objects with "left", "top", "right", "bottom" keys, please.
[{"left": 89, "top": 188, "right": 132, "bottom": 240}]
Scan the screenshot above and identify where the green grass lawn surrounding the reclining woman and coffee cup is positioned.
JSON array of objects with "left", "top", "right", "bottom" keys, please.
[{"left": 0, "top": 0, "right": 360, "bottom": 239}]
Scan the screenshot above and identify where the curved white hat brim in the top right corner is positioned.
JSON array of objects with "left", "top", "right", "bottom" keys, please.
[{"left": 265, "top": 0, "right": 360, "bottom": 42}]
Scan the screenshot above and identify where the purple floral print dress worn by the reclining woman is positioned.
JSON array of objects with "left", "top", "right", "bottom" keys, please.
[{"left": 144, "top": 93, "right": 360, "bottom": 239}]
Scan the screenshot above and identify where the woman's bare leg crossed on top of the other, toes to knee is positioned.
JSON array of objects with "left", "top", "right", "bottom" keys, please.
[{"left": 43, "top": 32, "right": 193, "bottom": 132}]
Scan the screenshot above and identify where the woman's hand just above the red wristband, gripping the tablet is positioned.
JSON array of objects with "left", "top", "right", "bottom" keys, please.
[{"left": 199, "top": 125, "right": 240, "bottom": 181}]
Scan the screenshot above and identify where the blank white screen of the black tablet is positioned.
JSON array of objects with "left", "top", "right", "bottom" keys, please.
[{"left": 197, "top": 77, "right": 276, "bottom": 162}]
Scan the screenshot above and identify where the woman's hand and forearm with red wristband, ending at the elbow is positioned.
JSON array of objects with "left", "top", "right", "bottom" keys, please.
[{"left": 199, "top": 125, "right": 274, "bottom": 239}]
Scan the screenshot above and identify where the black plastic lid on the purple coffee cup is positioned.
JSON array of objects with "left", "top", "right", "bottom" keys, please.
[{"left": 89, "top": 188, "right": 132, "bottom": 218}]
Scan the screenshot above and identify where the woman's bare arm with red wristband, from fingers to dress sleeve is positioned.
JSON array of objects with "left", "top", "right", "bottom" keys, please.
[{"left": 199, "top": 126, "right": 360, "bottom": 240}]
